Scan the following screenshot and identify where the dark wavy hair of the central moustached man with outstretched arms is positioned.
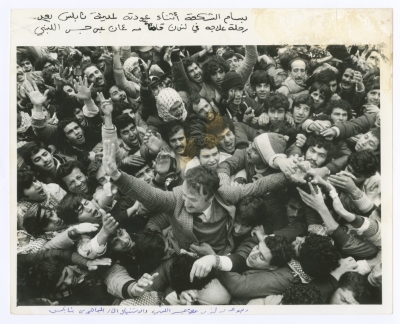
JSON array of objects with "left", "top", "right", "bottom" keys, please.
[{"left": 185, "top": 165, "right": 219, "bottom": 199}]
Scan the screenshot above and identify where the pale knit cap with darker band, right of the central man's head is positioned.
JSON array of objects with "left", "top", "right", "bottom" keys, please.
[{"left": 254, "top": 133, "right": 286, "bottom": 164}]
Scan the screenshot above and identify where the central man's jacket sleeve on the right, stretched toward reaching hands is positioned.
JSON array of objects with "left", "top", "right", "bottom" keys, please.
[{"left": 218, "top": 173, "right": 288, "bottom": 205}]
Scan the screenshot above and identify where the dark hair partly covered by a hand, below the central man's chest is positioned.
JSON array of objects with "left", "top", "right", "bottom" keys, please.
[{"left": 169, "top": 254, "right": 214, "bottom": 296}]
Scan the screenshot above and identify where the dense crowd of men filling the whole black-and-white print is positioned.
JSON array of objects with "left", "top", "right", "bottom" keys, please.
[{"left": 12, "top": 45, "right": 384, "bottom": 306}]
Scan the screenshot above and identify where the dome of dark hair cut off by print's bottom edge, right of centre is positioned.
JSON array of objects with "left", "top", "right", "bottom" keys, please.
[{"left": 282, "top": 283, "right": 325, "bottom": 305}]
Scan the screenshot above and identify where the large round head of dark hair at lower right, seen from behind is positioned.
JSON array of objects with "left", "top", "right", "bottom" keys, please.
[{"left": 298, "top": 234, "right": 341, "bottom": 279}]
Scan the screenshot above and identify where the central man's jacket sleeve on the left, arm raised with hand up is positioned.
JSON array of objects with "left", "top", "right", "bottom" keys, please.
[{"left": 114, "top": 171, "right": 176, "bottom": 213}]
